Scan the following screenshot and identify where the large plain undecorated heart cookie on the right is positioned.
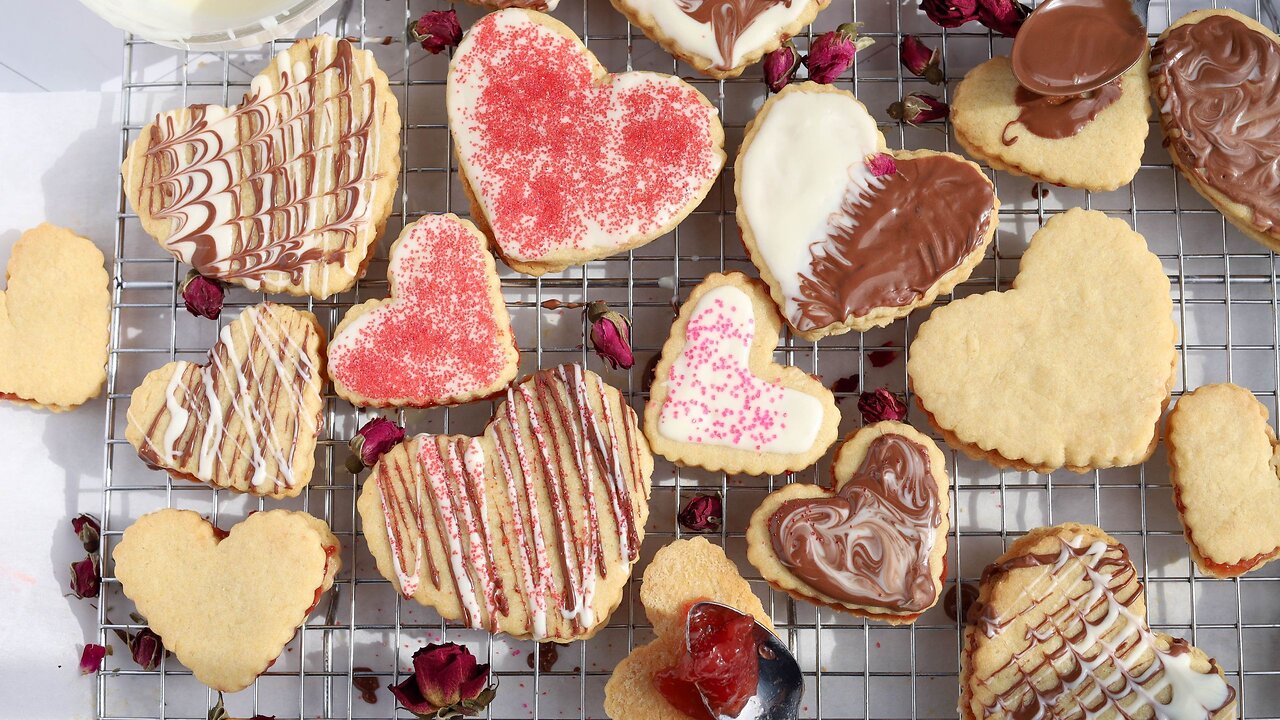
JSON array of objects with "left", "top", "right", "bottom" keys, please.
[{"left": 906, "top": 208, "right": 1178, "bottom": 473}]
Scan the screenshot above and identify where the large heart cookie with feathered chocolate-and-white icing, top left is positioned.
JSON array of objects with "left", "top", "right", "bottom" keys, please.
[{"left": 122, "top": 35, "right": 401, "bottom": 299}]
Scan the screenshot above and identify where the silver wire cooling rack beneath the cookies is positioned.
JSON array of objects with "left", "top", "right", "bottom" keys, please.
[{"left": 97, "top": 0, "right": 1280, "bottom": 719}]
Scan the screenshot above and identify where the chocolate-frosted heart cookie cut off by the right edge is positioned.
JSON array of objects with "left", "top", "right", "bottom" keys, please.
[{"left": 1151, "top": 10, "right": 1280, "bottom": 250}]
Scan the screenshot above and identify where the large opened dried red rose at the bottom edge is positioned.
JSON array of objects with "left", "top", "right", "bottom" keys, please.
[{"left": 388, "top": 643, "right": 497, "bottom": 717}]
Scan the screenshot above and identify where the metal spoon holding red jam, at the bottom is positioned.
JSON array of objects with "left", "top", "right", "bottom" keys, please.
[{"left": 685, "top": 601, "right": 804, "bottom": 720}]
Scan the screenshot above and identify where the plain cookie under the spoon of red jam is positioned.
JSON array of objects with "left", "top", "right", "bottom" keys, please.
[{"left": 604, "top": 537, "right": 773, "bottom": 720}]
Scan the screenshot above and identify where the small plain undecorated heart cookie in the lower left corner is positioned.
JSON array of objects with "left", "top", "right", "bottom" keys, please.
[{"left": 111, "top": 509, "right": 342, "bottom": 693}]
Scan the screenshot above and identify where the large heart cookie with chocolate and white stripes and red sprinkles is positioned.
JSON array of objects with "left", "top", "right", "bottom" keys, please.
[{"left": 357, "top": 365, "right": 653, "bottom": 642}]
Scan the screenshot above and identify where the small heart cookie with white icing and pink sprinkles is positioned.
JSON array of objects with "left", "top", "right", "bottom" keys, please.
[{"left": 644, "top": 273, "right": 840, "bottom": 475}]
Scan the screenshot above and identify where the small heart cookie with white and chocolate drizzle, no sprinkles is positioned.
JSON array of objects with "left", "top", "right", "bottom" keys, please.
[{"left": 125, "top": 302, "right": 324, "bottom": 497}]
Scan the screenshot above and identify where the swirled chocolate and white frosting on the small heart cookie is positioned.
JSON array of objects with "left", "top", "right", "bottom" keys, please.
[{"left": 769, "top": 434, "right": 942, "bottom": 612}]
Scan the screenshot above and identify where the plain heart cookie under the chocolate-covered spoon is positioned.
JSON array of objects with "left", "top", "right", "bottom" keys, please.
[{"left": 951, "top": 54, "right": 1151, "bottom": 191}]
